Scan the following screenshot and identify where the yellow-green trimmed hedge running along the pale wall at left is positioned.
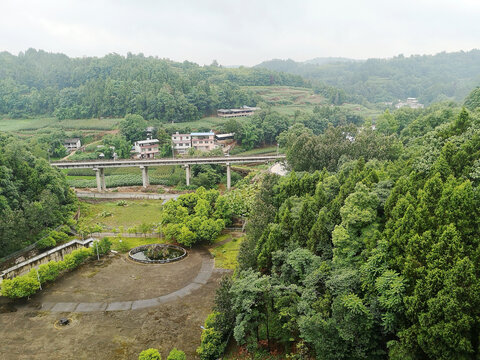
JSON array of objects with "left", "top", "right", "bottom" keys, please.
[{"left": 0, "top": 238, "right": 112, "bottom": 299}]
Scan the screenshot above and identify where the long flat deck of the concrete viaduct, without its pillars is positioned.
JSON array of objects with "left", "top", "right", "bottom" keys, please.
[{"left": 51, "top": 155, "right": 285, "bottom": 169}]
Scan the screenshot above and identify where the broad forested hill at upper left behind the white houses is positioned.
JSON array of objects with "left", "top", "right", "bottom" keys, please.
[{"left": 0, "top": 49, "right": 308, "bottom": 122}]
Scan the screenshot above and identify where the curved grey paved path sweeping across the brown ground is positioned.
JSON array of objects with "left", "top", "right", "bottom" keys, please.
[{"left": 41, "top": 249, "right": 215, "bottom": 312}]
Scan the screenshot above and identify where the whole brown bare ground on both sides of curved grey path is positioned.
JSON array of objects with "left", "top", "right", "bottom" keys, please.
[{"left": 0, "top": 250, "right": 221, "bottom": 360}]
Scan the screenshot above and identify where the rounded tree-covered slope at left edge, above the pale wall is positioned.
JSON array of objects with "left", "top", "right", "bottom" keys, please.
[{"left": 0, "top": 133, "right": 76, "bottom": 257}]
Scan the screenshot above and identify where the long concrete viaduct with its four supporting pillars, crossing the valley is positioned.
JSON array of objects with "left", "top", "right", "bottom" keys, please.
[{"left": 51, "top": 155, "right": 285, "bottom": 191}]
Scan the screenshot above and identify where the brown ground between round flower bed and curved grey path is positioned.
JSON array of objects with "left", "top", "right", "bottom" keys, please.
[{"left": 28, "top": 250, "right": 202, "bottom": 303}]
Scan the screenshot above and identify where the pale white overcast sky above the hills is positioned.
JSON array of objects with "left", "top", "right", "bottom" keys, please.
[{"left": 0, "top": 0, "right": 480, "bottom": 65}]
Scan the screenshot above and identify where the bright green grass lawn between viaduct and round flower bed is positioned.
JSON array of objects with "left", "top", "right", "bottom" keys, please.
[{"left": 81, "top": 200, "right": 162, "bottom": 232}]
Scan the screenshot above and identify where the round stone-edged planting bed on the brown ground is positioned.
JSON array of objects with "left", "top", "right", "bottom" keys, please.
[{"left": 128, "top": 244, "right": 187, "bottom": 264}]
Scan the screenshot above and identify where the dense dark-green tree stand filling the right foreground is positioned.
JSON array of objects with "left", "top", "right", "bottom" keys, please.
[{"left": 199, "top": 95, "right": 480, "bottom": 359}]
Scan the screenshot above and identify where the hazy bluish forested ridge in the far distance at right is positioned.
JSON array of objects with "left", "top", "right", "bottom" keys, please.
[{"left": 256, "top": 50, "right": 480, "bottom": 104}]
